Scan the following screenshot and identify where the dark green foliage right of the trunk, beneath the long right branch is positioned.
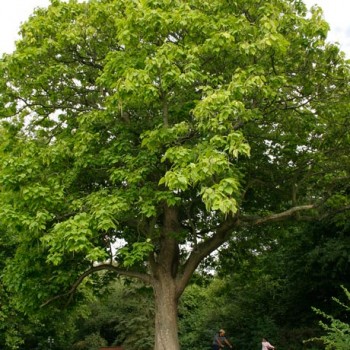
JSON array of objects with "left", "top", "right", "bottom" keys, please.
[{"left": 180, "top": 219, "right": 350, "bottom": 350}]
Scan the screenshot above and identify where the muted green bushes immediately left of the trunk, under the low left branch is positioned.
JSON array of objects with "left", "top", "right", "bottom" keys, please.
[{"left": 70, "top": 280, "right": 154, "bottom": 350}]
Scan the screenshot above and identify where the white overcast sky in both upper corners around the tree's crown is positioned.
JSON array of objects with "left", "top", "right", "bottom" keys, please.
[{"left": 0, "top": 0, "right": 350, "bottom": 57}]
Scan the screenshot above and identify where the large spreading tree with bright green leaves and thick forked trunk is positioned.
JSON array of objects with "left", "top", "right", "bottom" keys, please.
[{"left": 0, "top": 0, "right": 349, "bottom": 350}]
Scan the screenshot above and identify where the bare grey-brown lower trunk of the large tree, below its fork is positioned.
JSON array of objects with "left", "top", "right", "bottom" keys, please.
[{"left": 153, "top": 274, "right": 180, "bottom": 350}]
